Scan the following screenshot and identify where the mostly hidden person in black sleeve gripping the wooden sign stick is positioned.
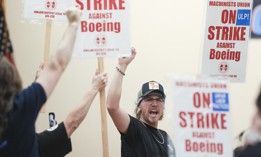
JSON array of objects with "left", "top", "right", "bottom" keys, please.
[{"left": 36, "top": 64, "right": 108, "bottom": 157}]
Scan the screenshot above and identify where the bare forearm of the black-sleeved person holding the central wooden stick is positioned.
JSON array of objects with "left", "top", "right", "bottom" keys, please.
[{"left": 64, "top": 89, "right": 98, "bottom": 137}]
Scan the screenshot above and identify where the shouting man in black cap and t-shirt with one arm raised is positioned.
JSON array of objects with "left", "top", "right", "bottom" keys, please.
[{"left": 106, "top": 48, "right": 175, "bottom": 157}]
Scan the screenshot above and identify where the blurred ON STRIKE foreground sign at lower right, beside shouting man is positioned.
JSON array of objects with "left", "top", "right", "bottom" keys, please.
[{"left": 172, "top": 79, "right": 233, "bottom": 157}]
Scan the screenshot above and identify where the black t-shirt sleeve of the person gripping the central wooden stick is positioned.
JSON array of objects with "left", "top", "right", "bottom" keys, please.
[{"left": 36, "top": 123, "right": 72, "bottom": 157}]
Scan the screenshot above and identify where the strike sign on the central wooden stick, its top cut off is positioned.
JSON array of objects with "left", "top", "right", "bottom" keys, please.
[{"left": 74, "top": 0, "right": 131, "bottom": 57}]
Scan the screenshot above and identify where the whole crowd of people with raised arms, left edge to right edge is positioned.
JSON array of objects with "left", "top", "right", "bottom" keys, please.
[{"left": 0, "top": 2, "right": 261, "bottom": 157}]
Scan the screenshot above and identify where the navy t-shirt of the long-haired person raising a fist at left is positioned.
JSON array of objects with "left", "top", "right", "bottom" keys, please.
[{"left": 0, "top": 83, "right": 46, "bottom": 157}]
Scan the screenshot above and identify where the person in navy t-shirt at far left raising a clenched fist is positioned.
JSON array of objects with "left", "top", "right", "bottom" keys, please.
[{"left": 0, "top": 8, "right": 82, "bottom": 157}]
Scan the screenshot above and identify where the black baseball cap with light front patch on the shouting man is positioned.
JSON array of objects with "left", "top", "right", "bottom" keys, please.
[{"left": 136, "top": 81, "right": 166, "bottom": 105}]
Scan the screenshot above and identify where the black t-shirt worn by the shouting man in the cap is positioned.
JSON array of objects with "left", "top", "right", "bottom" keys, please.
[{"left": 121, "top": 116, "right": 175, "bottom": 157}]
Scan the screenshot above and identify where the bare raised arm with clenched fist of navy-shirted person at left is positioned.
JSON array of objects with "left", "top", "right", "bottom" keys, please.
[{"left": 36, "top": 8, "right": 82, "bottom": 97}]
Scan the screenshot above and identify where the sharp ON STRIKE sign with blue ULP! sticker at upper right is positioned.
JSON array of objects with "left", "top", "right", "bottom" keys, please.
[{"left": 201, "top": 0, "right": 252, "bottom": 82}]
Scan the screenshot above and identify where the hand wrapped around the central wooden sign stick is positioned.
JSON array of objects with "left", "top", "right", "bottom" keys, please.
[{"left": 92, "top": 69, "right": 108, "bottom": 91}]
